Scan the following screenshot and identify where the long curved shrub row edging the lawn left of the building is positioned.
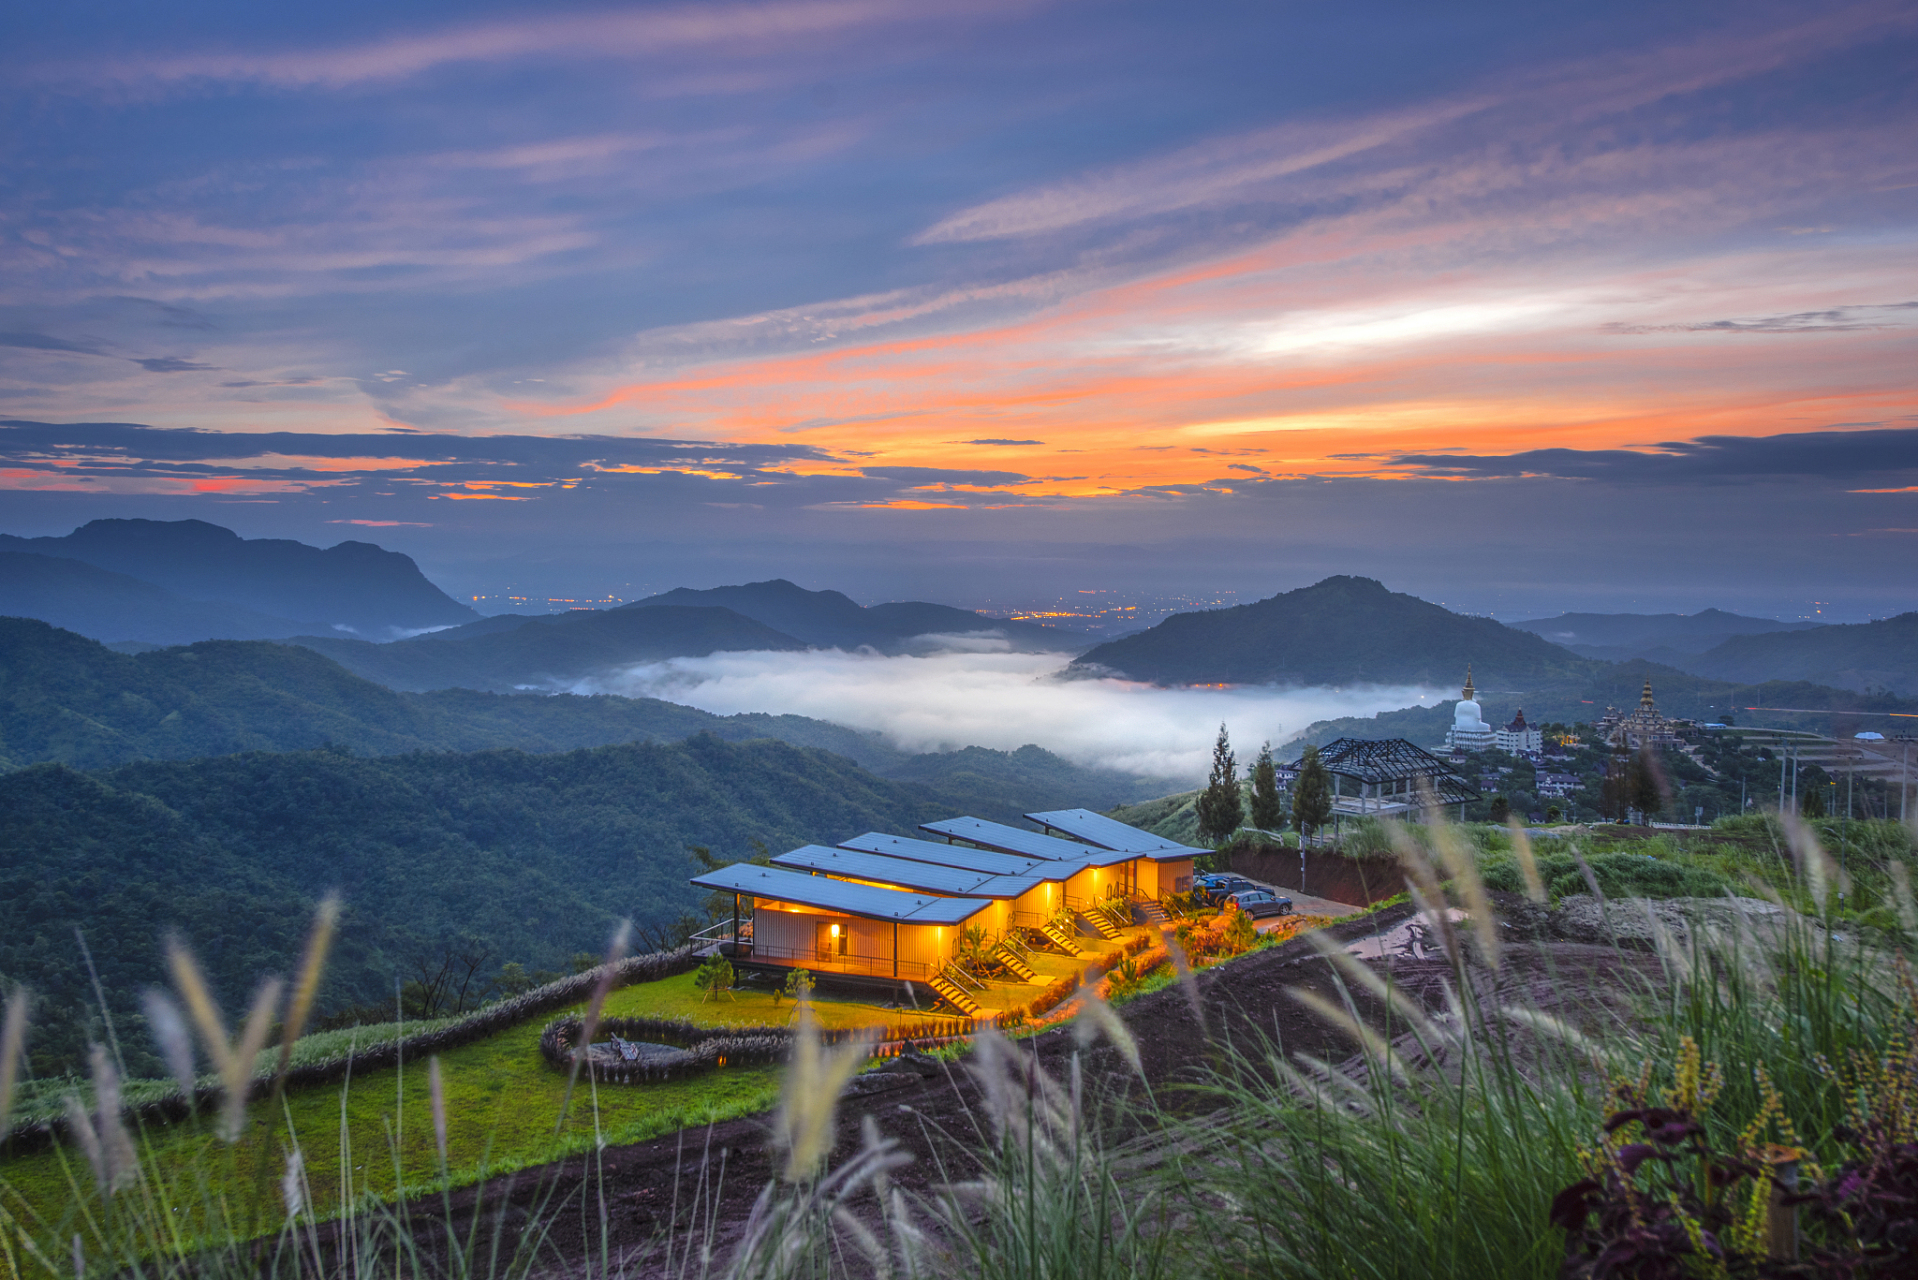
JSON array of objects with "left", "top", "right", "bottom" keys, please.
[{"left": 0, "top": 946, "right": 698, "bottom": 1155}]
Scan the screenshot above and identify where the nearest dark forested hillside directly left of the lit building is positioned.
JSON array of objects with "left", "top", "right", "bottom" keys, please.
[{"left": 0, "top": 735, "right": 1112, "bottom": 1073}]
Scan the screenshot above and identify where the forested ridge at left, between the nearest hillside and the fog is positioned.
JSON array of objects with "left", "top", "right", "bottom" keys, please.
[{"left": 0, "top": 618, "right": 1158, "bottom": 808}]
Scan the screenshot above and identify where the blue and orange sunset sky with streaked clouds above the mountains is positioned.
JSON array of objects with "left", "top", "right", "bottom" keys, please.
[{"left": 0, "top": 0, "right": 1918, "bottom": 620}]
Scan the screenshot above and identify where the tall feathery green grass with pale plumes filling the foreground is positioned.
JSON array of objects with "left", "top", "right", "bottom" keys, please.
[{"left": 0, "top": 825, "right": 1918, "bottom": 1280}]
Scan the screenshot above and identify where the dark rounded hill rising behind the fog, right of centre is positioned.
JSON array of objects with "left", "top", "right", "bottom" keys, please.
[{"left": 1074, "top": 578, "right": 1594, "bottom": 687}]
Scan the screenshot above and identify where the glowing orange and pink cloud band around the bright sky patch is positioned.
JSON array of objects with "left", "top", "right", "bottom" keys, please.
[{"left": 508, "top": 225, "right": 1918, "bottom": 499}]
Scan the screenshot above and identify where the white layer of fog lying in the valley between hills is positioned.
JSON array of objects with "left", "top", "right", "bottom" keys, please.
[{"left": 575, "top": 645, "right": 1442, "bottom": 779}]
